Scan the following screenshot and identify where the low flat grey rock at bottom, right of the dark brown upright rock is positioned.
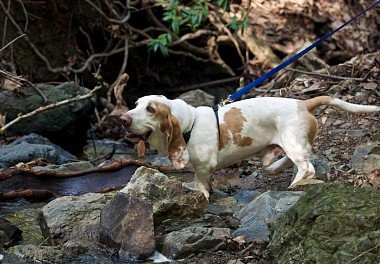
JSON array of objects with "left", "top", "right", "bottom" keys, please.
[{"left": 162, "top": 227, "right": 229, "bottom": 259}]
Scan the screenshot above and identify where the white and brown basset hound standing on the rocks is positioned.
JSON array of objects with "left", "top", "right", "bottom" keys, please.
[{"left": 121, "top": 95, "right": 380, "bottom": 198}]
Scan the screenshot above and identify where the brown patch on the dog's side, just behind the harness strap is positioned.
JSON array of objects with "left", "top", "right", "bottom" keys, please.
[{"left": 220, "top": 107, "right": 253, "bottom": 149}]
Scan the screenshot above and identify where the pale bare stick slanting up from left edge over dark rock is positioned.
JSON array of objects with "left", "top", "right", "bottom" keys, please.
[{"left": 0, "top": 85, "right": 103, "bottom": 135}]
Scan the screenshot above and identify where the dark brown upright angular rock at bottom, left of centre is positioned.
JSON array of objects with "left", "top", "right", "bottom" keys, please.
[{"left": 99, "top": 193, "right": 156, "bottom": 259}]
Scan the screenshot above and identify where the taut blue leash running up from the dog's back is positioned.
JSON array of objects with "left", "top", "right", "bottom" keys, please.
[{"left": 227, "top": 0, "right": 380, "bottom": 102}]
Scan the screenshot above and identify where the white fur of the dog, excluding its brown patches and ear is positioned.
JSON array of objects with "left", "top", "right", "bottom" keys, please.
[{"left": 123, "top": 95, "right": 380, "bottom": 198}]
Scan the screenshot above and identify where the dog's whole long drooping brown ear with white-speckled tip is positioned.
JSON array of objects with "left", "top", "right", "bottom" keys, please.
[{"left": 156, "top": 103, "right": 189, "bottom": 169}]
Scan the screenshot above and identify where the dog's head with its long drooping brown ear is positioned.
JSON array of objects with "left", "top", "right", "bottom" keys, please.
[{"left": 120, "top": 95, "right": 189, "bottom": 169}]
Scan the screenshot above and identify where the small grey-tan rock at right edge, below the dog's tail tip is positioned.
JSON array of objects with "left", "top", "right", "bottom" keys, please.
[{"left": 351, "top": 145, "right": 380, "bottom": 174}]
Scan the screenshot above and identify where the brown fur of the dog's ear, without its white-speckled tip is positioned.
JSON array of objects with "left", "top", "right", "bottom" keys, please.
[{"left": 152, "top": 102, "right": 186, "bottom": 165}]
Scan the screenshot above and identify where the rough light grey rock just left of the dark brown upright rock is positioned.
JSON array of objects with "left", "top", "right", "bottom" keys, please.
[{"left": 41, "top": 193, "right": 107, "bottom": 244}]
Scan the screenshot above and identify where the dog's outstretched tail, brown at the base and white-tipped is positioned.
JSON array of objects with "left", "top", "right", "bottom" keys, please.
[{"left": 304, "top": 96, "right": 380, "bottom": 113}]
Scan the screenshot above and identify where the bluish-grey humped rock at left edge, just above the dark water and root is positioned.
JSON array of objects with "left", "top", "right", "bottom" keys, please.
[{"left": 0, "top": 134, "right": 77, "bottom": 168}]
